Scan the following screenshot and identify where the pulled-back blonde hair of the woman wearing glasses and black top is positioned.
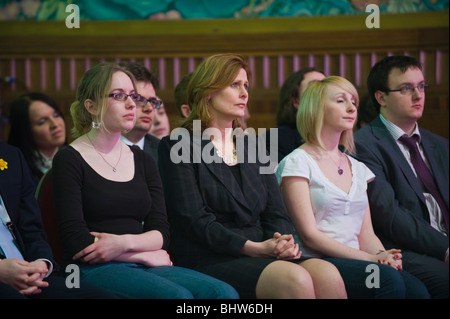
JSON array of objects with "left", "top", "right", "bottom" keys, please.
[{"left": 70, "top": 62, "right": 136, "bottom": 138}]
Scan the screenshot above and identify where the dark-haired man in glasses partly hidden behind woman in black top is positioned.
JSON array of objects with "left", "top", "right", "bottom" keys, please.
[{"left": 120, "top": 62, "right": 162, "bottom": 164}]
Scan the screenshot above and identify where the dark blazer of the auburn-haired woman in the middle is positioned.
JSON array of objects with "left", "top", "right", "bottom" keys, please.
[{"left": 158, "top": 132, "right": 293, "bottom": 268}]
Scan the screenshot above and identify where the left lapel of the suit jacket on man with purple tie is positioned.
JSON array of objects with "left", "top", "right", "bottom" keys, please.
[{"left": 372, "top": 117, "right": 425, "bottom": 204}]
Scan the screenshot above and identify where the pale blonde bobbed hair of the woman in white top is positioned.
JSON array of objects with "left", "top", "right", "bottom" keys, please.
[{"left": 297, "top": 76, "right": 359, "bottom": 154}]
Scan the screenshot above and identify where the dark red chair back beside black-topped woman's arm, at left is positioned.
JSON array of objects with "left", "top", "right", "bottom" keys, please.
[{"left": 35, "top": 169, "right": 62, "bottom": 265}]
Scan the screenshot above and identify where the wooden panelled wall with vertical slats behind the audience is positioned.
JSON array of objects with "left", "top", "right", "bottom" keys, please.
[{"left": 0, "top": 11, "right": 449, "bottom": 139}]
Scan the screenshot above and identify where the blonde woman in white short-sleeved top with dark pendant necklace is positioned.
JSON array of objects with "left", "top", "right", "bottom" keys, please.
[{"left": 277, "top": 76, "right": 429, "bottom": 298}]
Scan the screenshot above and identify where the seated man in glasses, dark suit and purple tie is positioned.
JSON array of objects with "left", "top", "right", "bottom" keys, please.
[{"left": 355, "top": 56, "right": 449, "bottom": 298}]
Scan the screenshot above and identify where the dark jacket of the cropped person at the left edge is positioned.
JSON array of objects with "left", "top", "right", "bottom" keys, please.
[{"left": 0, "top": 142, "right": 56, "bottom": 267}]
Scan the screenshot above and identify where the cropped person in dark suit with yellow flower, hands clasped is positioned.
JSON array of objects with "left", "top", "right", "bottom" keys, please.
[{"left": 0, "top": 142, "right": 116, "bottom": 299}]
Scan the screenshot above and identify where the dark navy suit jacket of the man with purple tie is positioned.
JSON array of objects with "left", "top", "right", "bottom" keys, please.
[{"left": 355, "top": 117, "right": 449, "bottom": 260}]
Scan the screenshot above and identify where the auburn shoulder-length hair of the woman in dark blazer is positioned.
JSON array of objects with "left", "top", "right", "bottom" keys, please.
[{"left": 181, "top": 53, "right": 250, "bottom": 132}]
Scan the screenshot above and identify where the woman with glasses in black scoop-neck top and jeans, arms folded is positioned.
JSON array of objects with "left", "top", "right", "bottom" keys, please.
[{"left": 52, "top": 63, "right": 238, "bottom": 299}]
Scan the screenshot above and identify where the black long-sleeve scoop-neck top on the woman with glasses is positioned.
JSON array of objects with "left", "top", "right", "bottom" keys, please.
[{"left": 52, "top": 146, "right": 170, "bottom": 263}]
